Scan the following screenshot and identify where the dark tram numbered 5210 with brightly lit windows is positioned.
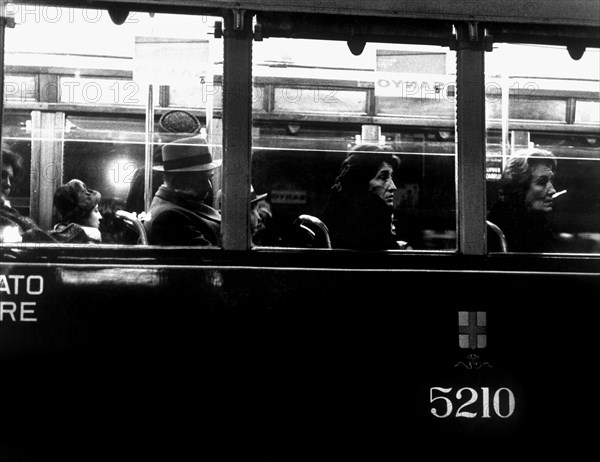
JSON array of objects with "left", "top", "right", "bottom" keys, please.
[{"left": 0, "top": 0, "right": 600, "bottom": 461}]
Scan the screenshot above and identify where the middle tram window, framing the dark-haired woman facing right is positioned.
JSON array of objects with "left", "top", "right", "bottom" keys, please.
[{"left": 252, "top": 38, "right": 457, "bottom": 251}]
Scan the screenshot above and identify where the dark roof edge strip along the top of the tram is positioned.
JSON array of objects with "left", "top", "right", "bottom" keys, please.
[{"left": 4, "top": 0, "right": 600, "bottom": 27}]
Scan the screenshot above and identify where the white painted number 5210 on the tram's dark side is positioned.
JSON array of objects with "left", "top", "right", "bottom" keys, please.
[{"left": 429, "top": 387, "right": 515, "bottom": 419}]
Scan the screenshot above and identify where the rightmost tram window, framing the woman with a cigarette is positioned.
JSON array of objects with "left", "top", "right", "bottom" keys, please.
[{"left": 486, "top": 44, "right": 600, "bottom": 253}]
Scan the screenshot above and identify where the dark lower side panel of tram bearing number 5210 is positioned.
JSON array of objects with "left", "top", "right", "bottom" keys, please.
[{"left": 0, "top": 264, "right": 600, "bottom": 458}]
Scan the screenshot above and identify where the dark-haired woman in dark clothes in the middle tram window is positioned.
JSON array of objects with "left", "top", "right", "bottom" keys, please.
[{"left": 323, "top": 144, "right": 406, "bottom": 250}]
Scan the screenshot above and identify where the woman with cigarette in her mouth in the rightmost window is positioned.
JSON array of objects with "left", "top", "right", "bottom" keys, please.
[{"left": 488, "top": 149, "right": 558, "bottom": 252}]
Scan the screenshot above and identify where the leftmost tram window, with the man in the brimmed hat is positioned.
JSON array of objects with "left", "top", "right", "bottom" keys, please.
[{"left": 2, "top": 8, "right": 223, "bottom": 246}]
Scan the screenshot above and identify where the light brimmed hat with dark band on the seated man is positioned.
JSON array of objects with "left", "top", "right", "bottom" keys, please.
[{"left": 153, "top": 136, "right": 222, "bottom": 172}]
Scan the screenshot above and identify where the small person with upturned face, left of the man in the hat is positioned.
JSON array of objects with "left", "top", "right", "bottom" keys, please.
[{"left": 50, "top": 179, "right": 102, "bottom": 243}]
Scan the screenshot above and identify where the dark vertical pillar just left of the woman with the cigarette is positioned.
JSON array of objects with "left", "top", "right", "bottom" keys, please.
[{"left": 456, "top": 23, "right": 486, "bottom": 255}]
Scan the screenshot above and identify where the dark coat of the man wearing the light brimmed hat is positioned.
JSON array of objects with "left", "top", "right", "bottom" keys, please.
[{"left": 144, "top": 185, "right": 221, "bottom": 246}]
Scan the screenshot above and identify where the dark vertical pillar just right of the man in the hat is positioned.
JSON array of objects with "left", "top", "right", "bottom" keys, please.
[{"left": 221, "top": 10, "right": 252, "bottom": 250}]
